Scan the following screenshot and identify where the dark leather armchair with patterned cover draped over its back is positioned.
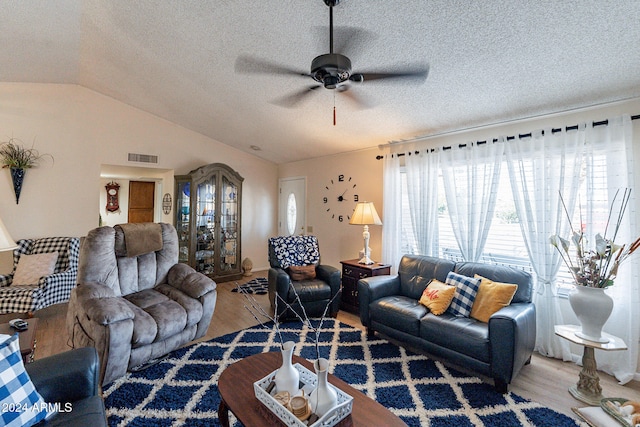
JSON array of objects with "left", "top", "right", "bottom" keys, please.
[{"left": 269, "top": 236, "right": 340, "bottom": 319}]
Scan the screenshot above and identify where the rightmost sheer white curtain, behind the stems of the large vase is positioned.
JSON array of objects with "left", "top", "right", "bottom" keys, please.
[{"left": 574, "top": 116, "right": 640, "bottom": 384}]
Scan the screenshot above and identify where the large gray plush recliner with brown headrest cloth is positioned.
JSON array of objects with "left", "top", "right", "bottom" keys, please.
[{"left": 67, "top": 223, "right": 217, "bottom": 384}]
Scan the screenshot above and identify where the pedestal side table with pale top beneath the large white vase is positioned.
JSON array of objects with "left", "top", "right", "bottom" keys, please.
[{"left": 555, "top": 325, "right": 627, "bottom": 406}]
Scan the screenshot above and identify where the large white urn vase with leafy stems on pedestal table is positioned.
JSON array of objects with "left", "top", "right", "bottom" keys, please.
[{"left": 569, "top": 285, "right": 613, "bottom": 343}]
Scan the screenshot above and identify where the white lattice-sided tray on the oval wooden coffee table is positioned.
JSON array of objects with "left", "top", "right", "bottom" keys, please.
[{"left": 253, "top": 363, "right": 353, "bottom": 427}]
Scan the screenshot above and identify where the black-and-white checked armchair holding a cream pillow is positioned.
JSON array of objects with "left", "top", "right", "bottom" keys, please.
[{"left": 0, "top": 237, "right": 80, "bottom": 314}]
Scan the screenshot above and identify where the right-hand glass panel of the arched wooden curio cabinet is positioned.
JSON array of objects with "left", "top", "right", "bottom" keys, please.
[{"left": 220, "top": 175, "right": 238, "bottom": 271}]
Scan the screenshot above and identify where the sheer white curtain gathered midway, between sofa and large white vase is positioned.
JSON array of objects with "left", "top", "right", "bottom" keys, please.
[{"left": 505, "top": 126, "right": 585, "bottom": 360}]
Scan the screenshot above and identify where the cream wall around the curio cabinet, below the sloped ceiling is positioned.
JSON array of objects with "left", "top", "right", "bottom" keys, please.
[{"left": 0, "top": 83, "right": 278, "bottom": 273}]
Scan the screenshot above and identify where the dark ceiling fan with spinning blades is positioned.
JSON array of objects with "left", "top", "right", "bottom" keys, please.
[{"left": 235, "top": 0, "right": 429, "bottom": 115}]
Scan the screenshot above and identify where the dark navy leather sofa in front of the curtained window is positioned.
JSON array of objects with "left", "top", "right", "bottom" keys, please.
[{"left": 358, "top": 255, "right": 536, "bottom": 393}]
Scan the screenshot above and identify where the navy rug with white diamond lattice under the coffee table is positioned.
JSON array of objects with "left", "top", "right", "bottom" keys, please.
[{"left": 104, "top": 319, "right": 585, "bottom": 427}]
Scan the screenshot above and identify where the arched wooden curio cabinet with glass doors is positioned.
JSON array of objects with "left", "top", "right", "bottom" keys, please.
[{"left": 175, "top": 163, "right": 244, "bottom": 281}]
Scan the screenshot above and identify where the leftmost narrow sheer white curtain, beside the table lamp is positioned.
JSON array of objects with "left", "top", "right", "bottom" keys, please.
[{"left": 382, "top": 154, "right": 403, "bottom": 273}]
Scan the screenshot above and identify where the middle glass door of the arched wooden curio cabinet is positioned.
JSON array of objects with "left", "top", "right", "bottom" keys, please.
[{"left": 195, "top": 175, "right": 216, "bottom": 274}]
